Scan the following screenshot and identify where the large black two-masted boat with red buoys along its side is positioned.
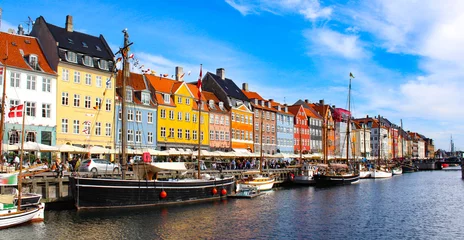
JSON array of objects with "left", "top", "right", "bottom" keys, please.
[{"left": 69, "top": 30, "right": 235, "bottom": 210}]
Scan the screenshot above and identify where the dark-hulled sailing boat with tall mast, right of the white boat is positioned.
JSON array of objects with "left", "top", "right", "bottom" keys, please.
[{"left": 314, "top": 73, "right": 359, "bottom": 186}]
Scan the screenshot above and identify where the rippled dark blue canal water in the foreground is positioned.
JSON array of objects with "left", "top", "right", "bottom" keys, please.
[{"left": 0, "top": 168, "right": 464, "bottom": 240}]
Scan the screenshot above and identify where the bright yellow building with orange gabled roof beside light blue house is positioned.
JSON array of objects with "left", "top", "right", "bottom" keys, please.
[{"left": 145, "top": 70, "right": 209, "bottom": 151}]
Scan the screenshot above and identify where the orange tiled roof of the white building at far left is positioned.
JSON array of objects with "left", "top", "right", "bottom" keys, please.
[{"left": 0, "top": 32, "right": 56, "bottom": 75}]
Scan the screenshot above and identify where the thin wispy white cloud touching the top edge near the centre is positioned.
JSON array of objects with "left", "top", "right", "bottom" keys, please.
[{"left": 225, "top": 0, "right": 333, "bottom": 21}]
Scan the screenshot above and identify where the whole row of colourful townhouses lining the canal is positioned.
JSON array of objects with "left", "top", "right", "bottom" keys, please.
[{"left": 0, "top": 16, "right": 433, "bottom": 158}]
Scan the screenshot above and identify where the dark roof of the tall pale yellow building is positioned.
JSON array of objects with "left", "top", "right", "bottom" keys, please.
[{"left": 44, "top": 19, "right": 114, "bottom": 60}]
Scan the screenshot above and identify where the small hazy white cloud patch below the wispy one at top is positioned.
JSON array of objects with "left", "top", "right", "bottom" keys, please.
[{"left": 304, "top": 28, "right": 367, "bottom": 59}]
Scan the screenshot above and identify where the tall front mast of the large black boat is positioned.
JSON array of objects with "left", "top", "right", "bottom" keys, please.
[{"left": 120, "top": 29, "right": 130, "bottom": 180}]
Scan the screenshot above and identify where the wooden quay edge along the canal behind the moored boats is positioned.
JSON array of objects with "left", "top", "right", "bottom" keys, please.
[{"left": 0, "top": 168, "right": 296, "bottom": 203}]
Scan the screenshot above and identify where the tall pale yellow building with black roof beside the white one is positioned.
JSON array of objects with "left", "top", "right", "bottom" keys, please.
[{"left": 31, "top": 16, "right": 115, "bottom": 148}]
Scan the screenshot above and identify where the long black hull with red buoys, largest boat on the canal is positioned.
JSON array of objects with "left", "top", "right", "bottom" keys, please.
[{"left": 70, "top": 177, "right": 235, "bottom": 209}]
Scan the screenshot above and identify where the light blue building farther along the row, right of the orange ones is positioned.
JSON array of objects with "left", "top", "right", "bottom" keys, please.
[{"left": 269, "top": 99, "right": 294, "bottom": 154}]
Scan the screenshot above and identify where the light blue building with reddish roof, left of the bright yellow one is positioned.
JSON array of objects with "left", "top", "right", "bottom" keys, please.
[{"left": 115, "top": 73, "right": 157, "bottom": 149}]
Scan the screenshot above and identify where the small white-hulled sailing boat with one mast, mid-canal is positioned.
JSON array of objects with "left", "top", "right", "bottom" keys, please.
[{"left": 237, "top": 107, "right": 275, "bottom": 192}]
